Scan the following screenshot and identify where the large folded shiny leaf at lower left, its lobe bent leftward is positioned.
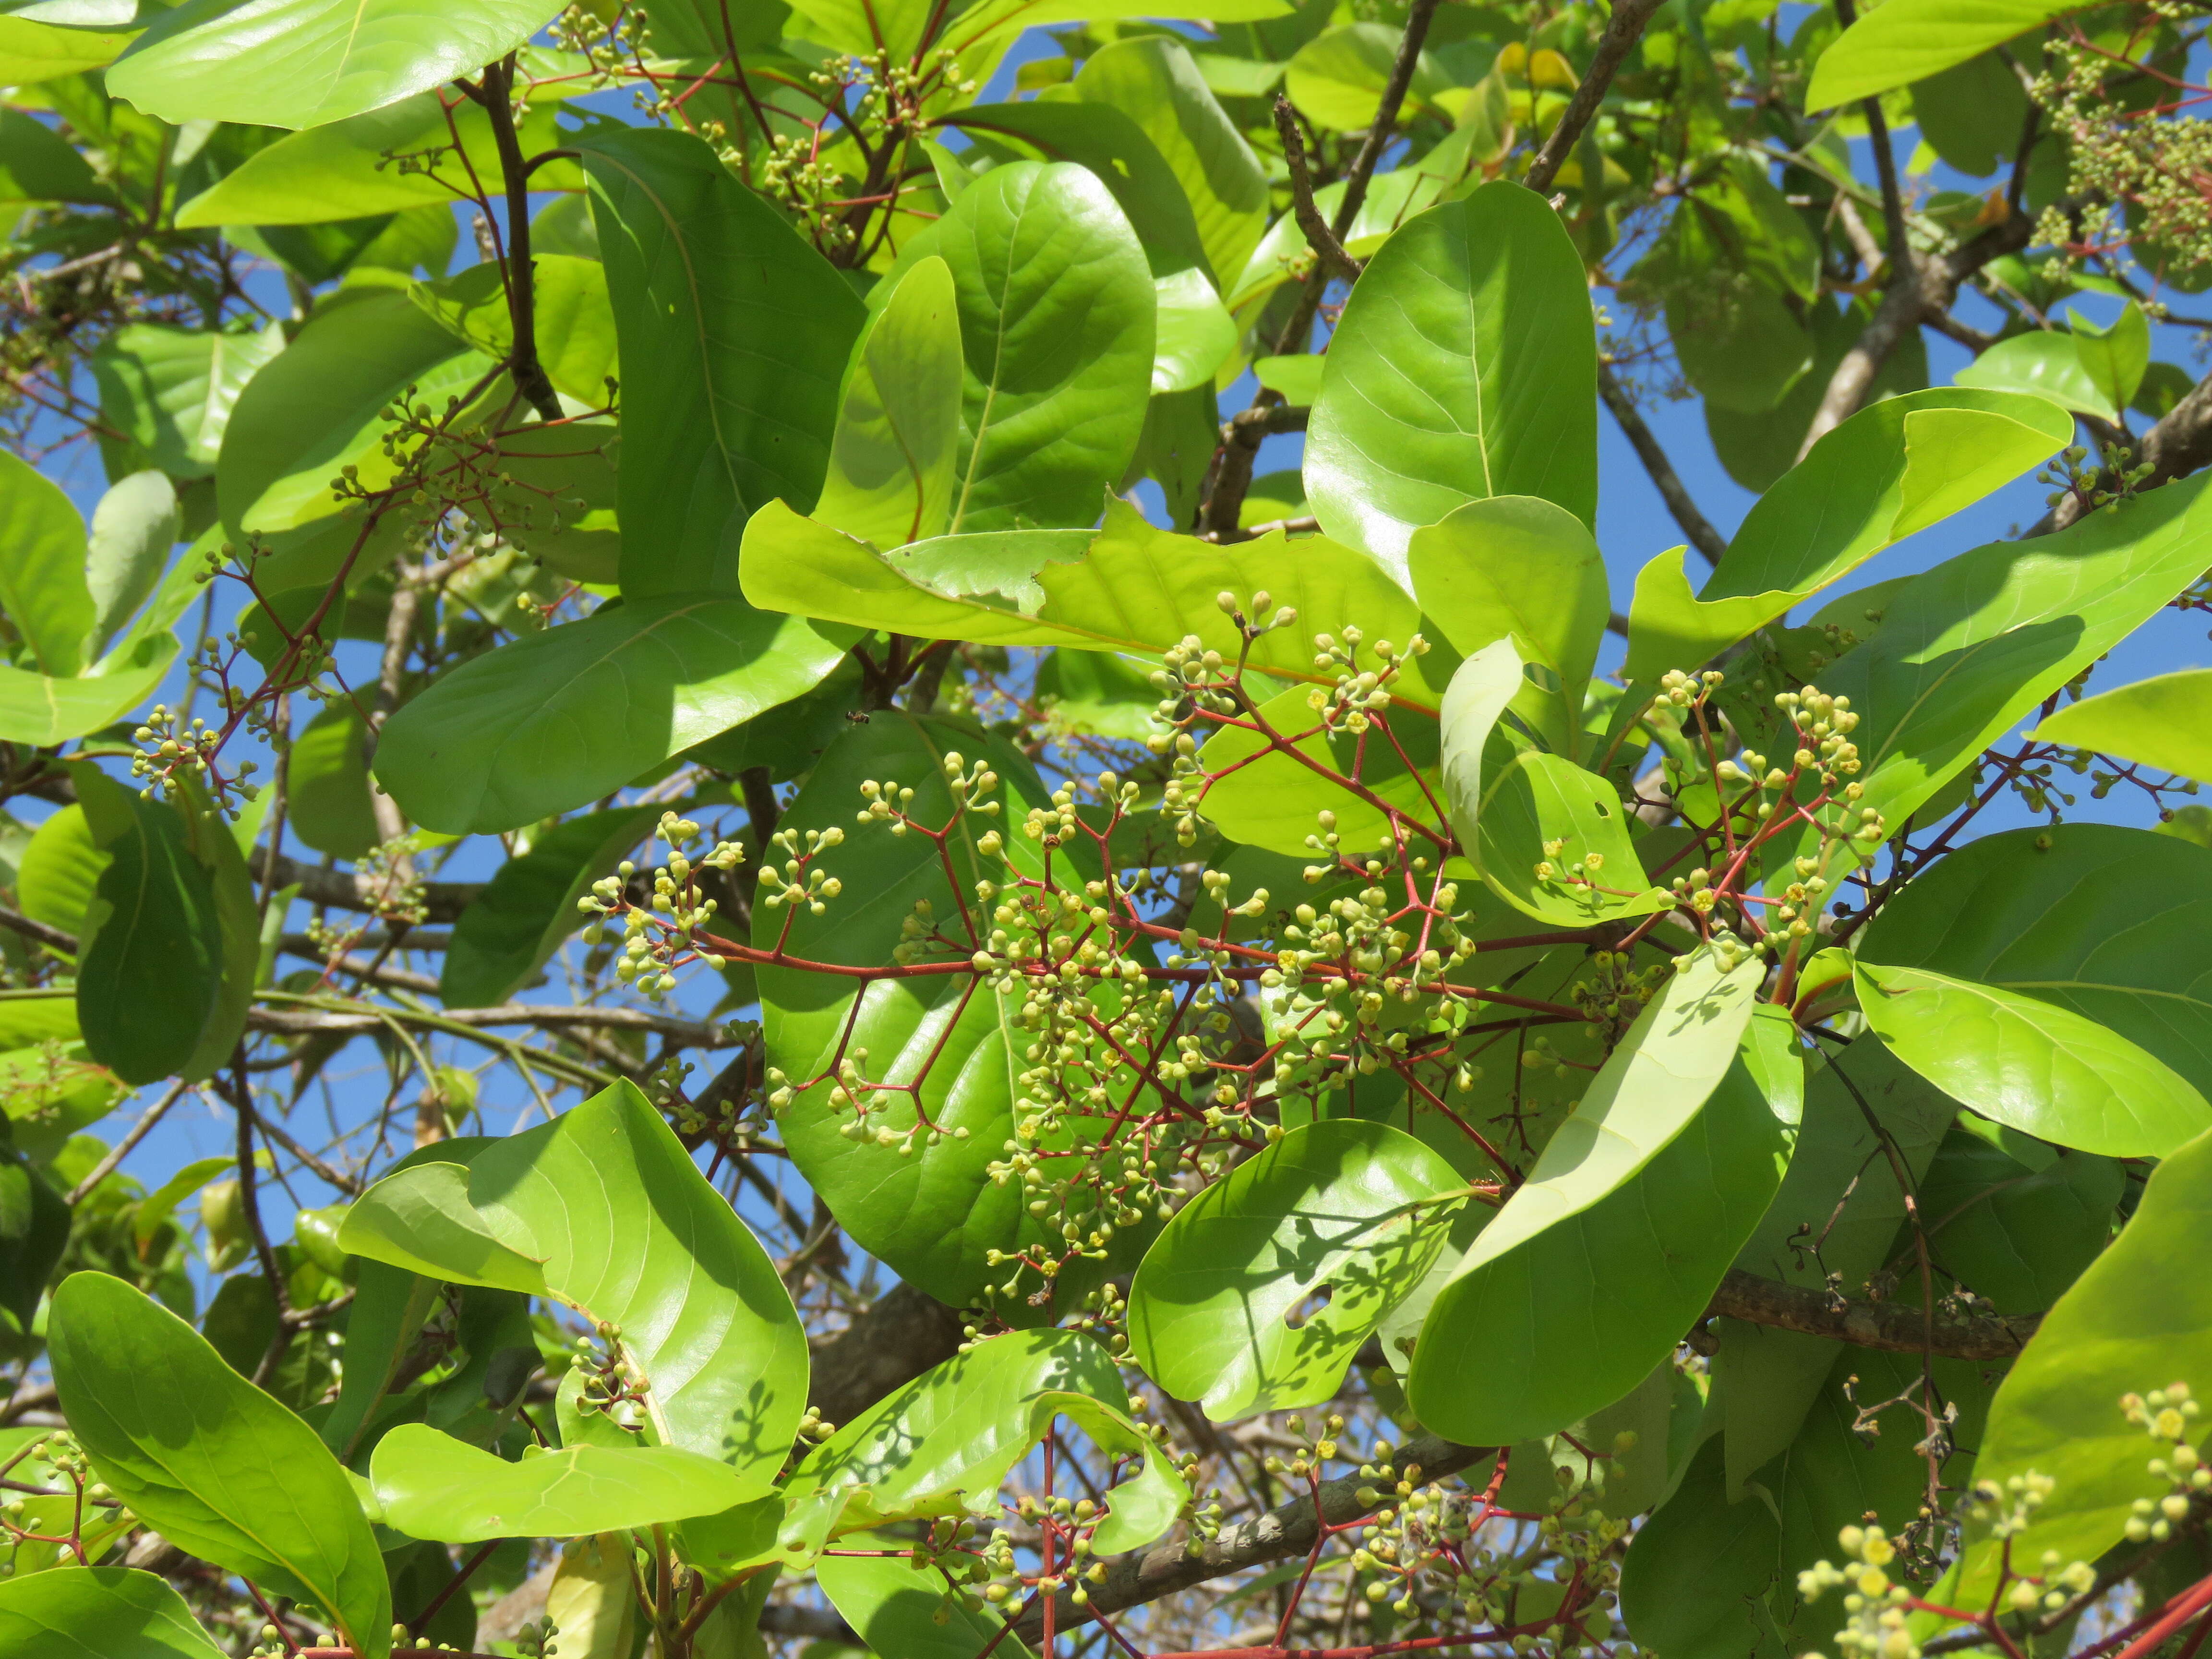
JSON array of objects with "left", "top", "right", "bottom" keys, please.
[{"left": 338, "top": 1082, "right": 807, "bottom": 1478}]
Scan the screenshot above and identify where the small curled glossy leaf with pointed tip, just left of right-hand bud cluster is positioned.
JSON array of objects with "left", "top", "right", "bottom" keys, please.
[{"left": 1453, "top": 750, "right": 1674, "bottom": 927}]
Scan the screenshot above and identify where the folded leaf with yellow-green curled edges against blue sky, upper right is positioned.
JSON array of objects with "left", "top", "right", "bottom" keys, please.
[{"left": 1622, "top": 389, "right": 2073, "bottom": 681}]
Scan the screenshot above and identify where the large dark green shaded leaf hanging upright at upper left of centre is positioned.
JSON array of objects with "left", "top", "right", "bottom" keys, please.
[{"left": 584, "top": 128, "right": 865, "bottom": 600}]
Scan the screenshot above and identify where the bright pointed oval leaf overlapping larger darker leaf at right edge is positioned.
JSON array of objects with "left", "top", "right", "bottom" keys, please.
[{"left": 1858, "top": 960, "right": 2212, "bottom": 1157}]
